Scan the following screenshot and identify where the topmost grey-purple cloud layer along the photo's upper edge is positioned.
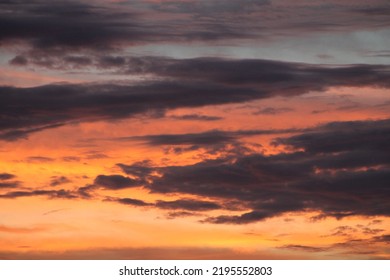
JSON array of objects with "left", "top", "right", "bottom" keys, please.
[{"left": 0, "top": 0, "right": 390, "bottom": 54}]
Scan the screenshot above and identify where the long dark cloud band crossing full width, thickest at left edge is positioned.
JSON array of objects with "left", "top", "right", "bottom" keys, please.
[{"left": 0, "top": 58, "right": 390, "bottom": 140}]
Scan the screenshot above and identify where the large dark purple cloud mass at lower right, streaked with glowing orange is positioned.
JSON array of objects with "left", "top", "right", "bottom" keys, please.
[{"left": 113, "top": 120, "right": 390, "bottom": 224}]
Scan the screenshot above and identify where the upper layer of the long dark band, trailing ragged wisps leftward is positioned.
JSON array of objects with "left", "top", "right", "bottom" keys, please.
[{"left": 13, "top": 53, "right": 390, "bottom": 89}]
